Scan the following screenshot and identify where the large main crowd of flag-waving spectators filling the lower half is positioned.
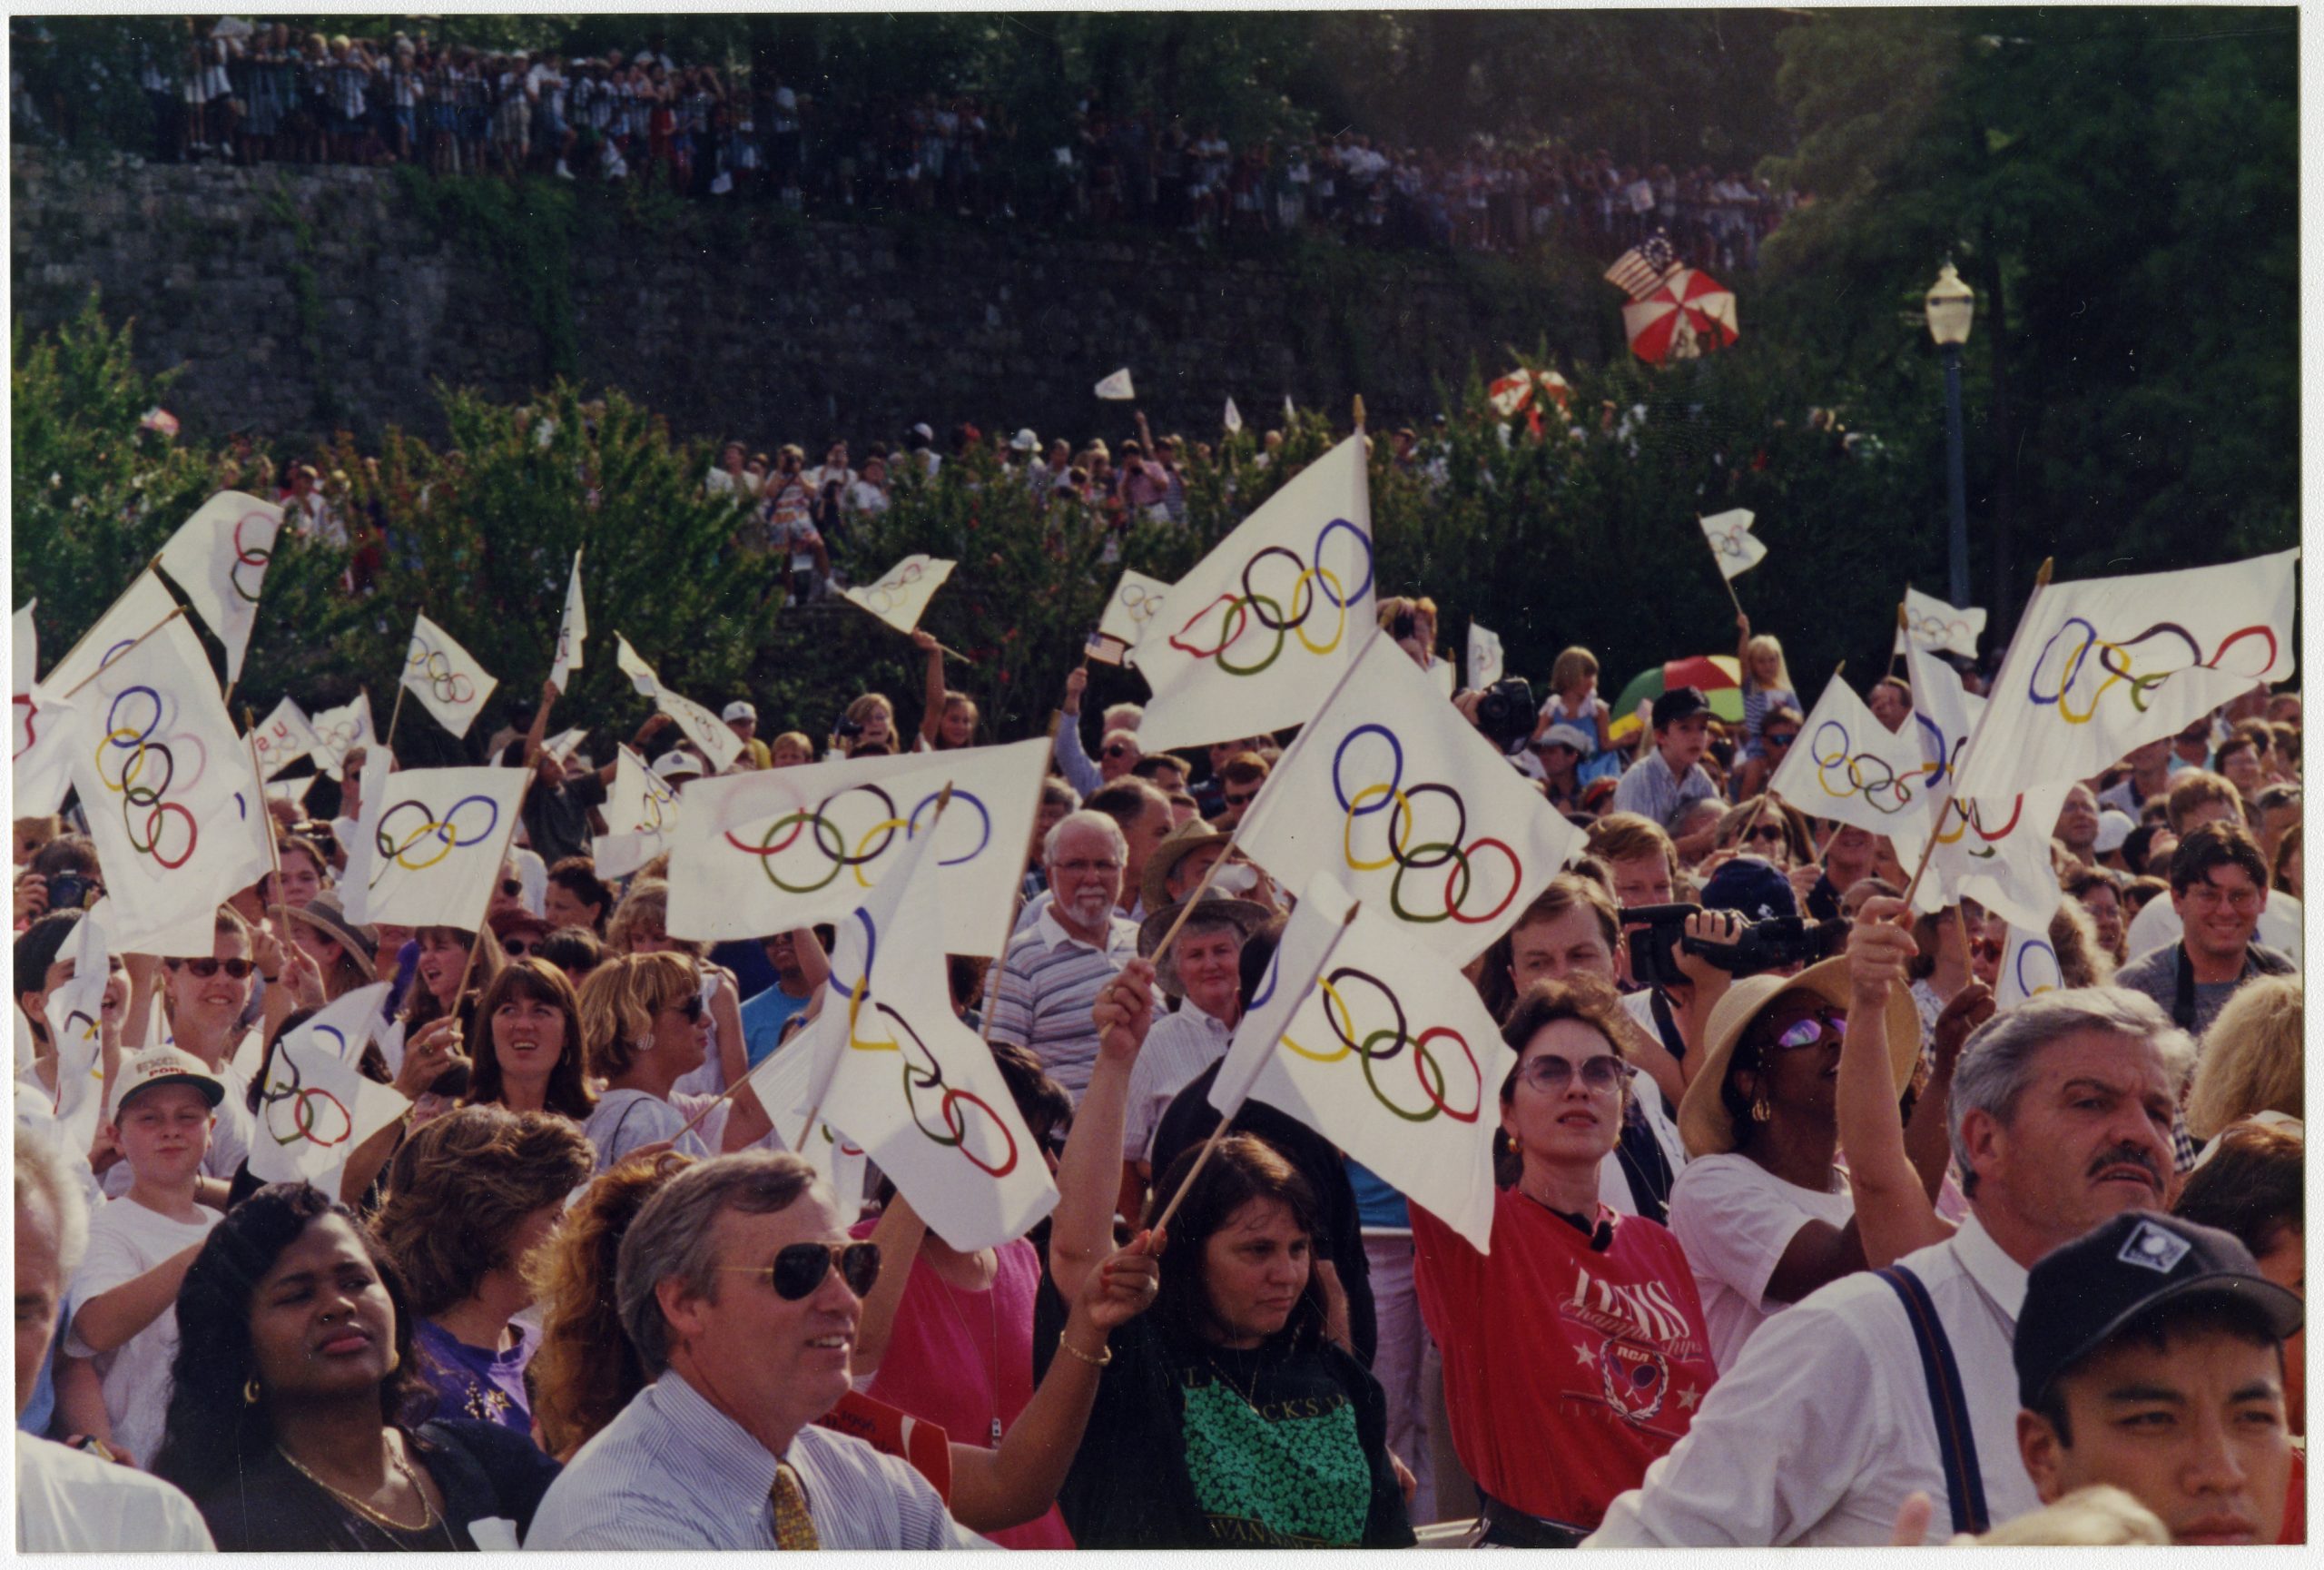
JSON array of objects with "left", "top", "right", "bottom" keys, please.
[{"left": 14, "top": 460, "right": 2306, "bottom": 1552}]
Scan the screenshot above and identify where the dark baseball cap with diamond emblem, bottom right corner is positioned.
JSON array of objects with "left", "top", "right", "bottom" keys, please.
[{"left": 2010, "top": 1210, "right": 2300, "bottom": 1407}]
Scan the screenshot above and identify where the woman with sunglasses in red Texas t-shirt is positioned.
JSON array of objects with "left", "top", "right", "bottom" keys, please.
[{"left": 1411, "top": 974, "right": 1718, "bottom": 1546}]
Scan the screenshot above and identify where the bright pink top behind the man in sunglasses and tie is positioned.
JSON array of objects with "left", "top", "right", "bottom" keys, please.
[{"left": 851, "top": 1221, "right": 1074, "bottom": 1549}]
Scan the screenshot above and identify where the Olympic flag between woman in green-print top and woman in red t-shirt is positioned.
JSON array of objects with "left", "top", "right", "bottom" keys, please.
[{"left": 1213, "top": 884, "right": 1515, "bottom": 1251}]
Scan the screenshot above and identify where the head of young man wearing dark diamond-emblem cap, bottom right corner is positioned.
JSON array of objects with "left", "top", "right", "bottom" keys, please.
[{"left": 2015, "top": 1212, "right": 2300, "bottom": 1545}]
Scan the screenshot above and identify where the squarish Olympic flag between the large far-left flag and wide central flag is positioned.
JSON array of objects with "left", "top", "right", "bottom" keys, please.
[{"left": 344, "top": 767, "right": 532, "bottom": 933}]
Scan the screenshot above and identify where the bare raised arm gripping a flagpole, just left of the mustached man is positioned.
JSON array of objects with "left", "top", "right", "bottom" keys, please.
[{"left": 1838, "top": 900, "right": 1952, "bottom": 1270}]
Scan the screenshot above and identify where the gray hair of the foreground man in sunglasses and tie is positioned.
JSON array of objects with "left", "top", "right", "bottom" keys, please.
[{"left": 614, "top": 1151, "right": 816, "bottom": 1377}]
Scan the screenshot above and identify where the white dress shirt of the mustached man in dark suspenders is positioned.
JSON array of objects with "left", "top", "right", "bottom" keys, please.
[{"left": 1587, "top": 1217, "right": 2041, "bottom": 1549}]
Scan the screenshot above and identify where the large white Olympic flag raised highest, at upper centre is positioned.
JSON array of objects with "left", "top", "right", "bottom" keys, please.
[{"left": 1129, "top": 438, "right": 1378, "bottom": 751}]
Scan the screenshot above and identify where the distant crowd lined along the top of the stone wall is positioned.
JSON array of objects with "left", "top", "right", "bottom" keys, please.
[{"left": 12, "top": 18, "right": 1797, "bottom": 272}]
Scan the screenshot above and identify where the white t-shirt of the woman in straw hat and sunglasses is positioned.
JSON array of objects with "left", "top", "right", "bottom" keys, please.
[{"left": 1671, "top": 1153, "right": 1856, "bottom": 1372}]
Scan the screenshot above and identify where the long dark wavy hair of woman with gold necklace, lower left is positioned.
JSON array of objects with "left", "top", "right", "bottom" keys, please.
[{"left": 153, "top": 1184, "right": 435, "bottom": 1500}]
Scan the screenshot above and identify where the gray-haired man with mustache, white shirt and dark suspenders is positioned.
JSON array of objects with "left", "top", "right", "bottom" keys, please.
[{"left": 1590, "top": 981, "right": 2194, "bottom": 1546}]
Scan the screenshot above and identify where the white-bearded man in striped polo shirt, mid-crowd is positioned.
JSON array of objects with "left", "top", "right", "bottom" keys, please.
[{"left": 992, "top": 812, "right": 1159, "bottom": 1102}]
